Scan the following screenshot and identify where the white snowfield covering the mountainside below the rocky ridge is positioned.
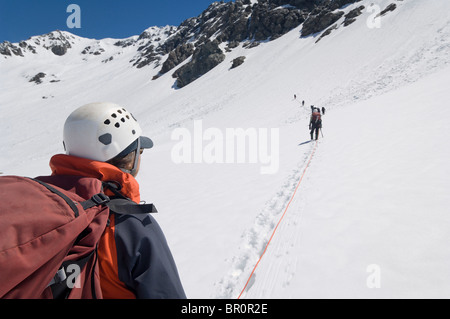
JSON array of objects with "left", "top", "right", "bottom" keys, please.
[{"left": 0, "top": 0, "right": 450, "bottom": 298}]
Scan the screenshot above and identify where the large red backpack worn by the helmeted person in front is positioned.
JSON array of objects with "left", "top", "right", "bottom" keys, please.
[{"left": 0, "top": 176, "right": 109, "bottom": 299}]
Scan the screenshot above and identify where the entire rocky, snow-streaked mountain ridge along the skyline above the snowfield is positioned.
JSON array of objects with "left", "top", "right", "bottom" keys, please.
[{"left": 0, "top": 0, "right": 399, "bottom": 88}]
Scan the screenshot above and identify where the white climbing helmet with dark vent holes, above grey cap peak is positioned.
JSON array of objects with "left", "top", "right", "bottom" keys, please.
[{"left": 64, "top": 103, "right": 153, "bottom": 162}]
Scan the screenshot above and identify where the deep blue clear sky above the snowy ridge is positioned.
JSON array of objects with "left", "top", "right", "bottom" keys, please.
[{"left": 0, "top": 0, "right": 219, "bottom": 42}]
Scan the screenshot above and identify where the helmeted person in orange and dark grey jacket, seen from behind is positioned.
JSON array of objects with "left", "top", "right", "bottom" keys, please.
[{"left": 55, "top": 103, "right": 186, "bottom": 299}]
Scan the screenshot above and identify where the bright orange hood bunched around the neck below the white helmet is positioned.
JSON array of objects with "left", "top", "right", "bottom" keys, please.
[{"left": 50, "top": 154, "right": 141, "bottom": 204}]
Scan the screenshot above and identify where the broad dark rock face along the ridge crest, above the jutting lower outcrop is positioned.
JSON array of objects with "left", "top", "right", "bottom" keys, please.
[{"left": 156, "top": 0, "right": 306, "bottom": 74}]
